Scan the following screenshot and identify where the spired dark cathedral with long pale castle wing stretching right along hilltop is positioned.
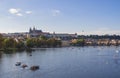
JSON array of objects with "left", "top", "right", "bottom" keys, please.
[{"left": 28, "top": 27, "right": 77, "bottom": 40}]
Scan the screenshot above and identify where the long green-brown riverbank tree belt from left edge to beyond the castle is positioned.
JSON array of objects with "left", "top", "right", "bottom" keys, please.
[{"left": 0, "top": 35, "right": 61, "bottom": 50}]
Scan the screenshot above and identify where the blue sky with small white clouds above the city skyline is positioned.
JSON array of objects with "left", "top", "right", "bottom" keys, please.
[{"left": 0, "top": 0, "right": 120, "bottom": 35}]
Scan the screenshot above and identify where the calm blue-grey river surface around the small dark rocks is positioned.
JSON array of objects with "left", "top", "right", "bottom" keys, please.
[{"left": 0, "top": 47, "right": 120, "bottom": 78}]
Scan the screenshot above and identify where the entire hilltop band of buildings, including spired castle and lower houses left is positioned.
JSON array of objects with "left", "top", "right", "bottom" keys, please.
[{"left": 2, "top": 27, "right": 78, "bottom": 40}]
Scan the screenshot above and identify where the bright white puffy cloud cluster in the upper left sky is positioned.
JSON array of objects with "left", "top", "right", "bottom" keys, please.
[{"left": 8, "top": 8, "right": 32, "bottom": 16}]
